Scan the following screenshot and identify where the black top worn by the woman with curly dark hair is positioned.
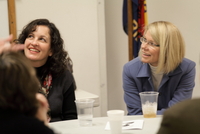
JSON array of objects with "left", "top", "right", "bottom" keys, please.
[{"left": 36, "top": 67, "right": 77, "bottom": 122}]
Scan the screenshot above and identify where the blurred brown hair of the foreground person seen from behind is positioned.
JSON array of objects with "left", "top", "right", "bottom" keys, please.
[{"left": 0, "top": 52, "right": 39, "bottom": 116}]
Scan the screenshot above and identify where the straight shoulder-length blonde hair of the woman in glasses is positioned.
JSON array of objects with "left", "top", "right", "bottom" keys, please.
[{"left": 141, "top": 21, "right": 185, "bottom": 74}]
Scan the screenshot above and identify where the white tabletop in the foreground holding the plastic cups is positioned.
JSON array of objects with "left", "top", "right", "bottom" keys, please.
[{"left": 49, "top": 115, "right": 162, "bottom": 134}]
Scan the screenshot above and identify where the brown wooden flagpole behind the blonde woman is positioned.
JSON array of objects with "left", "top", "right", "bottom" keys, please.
[{"left": 127, "top": 0, "right": 134, "bottom": 61}]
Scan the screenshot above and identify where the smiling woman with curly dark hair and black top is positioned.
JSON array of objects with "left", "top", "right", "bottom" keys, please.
[{"left": 17, "top": 19, "right": 77, "bottom": 122}]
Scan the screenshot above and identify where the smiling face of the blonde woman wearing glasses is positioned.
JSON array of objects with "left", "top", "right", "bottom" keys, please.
[{"left": 141, "top": 31, "right": 160, "bottom": 66}]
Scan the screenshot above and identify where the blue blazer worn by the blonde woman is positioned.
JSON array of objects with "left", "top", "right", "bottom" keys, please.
[{"left": 123, "top": 57, "right": 196, "bottom": 115}]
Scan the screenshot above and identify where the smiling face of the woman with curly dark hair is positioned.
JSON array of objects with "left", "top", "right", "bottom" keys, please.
[{"left": 24, "top": 25, "right": 52, "bottom": 67}]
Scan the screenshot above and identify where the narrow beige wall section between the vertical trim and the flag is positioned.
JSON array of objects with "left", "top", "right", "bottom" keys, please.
[{"left": 105, "top": 0, "right": 128, "bottom": 111}]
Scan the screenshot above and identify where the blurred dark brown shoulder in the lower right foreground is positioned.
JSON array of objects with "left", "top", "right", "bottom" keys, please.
[{"left": 157, "top": 98, "right": 200, "bottom": 134}]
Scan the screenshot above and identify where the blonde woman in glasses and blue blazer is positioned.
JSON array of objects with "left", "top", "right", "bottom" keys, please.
[{"left": 123, "top": 21, "right": 196, "bottom": 115}]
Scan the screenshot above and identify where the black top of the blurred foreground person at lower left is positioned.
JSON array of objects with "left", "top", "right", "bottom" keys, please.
[{"left": 0, "top": 109, "right": 54, "bottom": 134}]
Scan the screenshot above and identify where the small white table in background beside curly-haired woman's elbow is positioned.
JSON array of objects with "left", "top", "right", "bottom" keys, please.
[{"left": 75, "top": 89, "right": 99, "bottom": 107}]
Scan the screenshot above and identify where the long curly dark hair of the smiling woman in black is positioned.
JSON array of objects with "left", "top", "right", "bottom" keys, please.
[{"left": 17, "top": 19, "right": 73, "bottom": 81}]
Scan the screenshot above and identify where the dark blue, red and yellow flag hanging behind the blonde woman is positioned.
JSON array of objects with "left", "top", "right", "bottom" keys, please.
[{"left": 123, "top": 0, "right": 148, "bottom": 57}]
